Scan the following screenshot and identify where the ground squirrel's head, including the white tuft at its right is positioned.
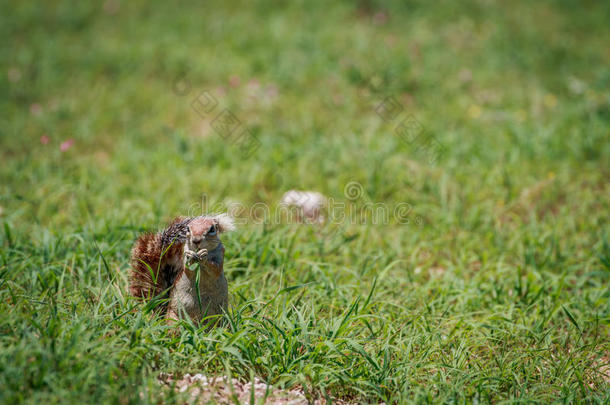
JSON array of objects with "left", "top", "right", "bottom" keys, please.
[{"left": 186, "top": 214, "right": 235, "bottom": 251}]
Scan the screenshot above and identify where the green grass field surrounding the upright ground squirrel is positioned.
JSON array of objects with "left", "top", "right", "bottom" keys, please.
[{"left": 0, "top": 0, "right": 610, "bottom": 403}]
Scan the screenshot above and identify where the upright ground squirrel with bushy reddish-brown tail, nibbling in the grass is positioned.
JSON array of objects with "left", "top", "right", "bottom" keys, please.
[{"left": 129, "top": 214, "right": 234, "bottom": 323}]
